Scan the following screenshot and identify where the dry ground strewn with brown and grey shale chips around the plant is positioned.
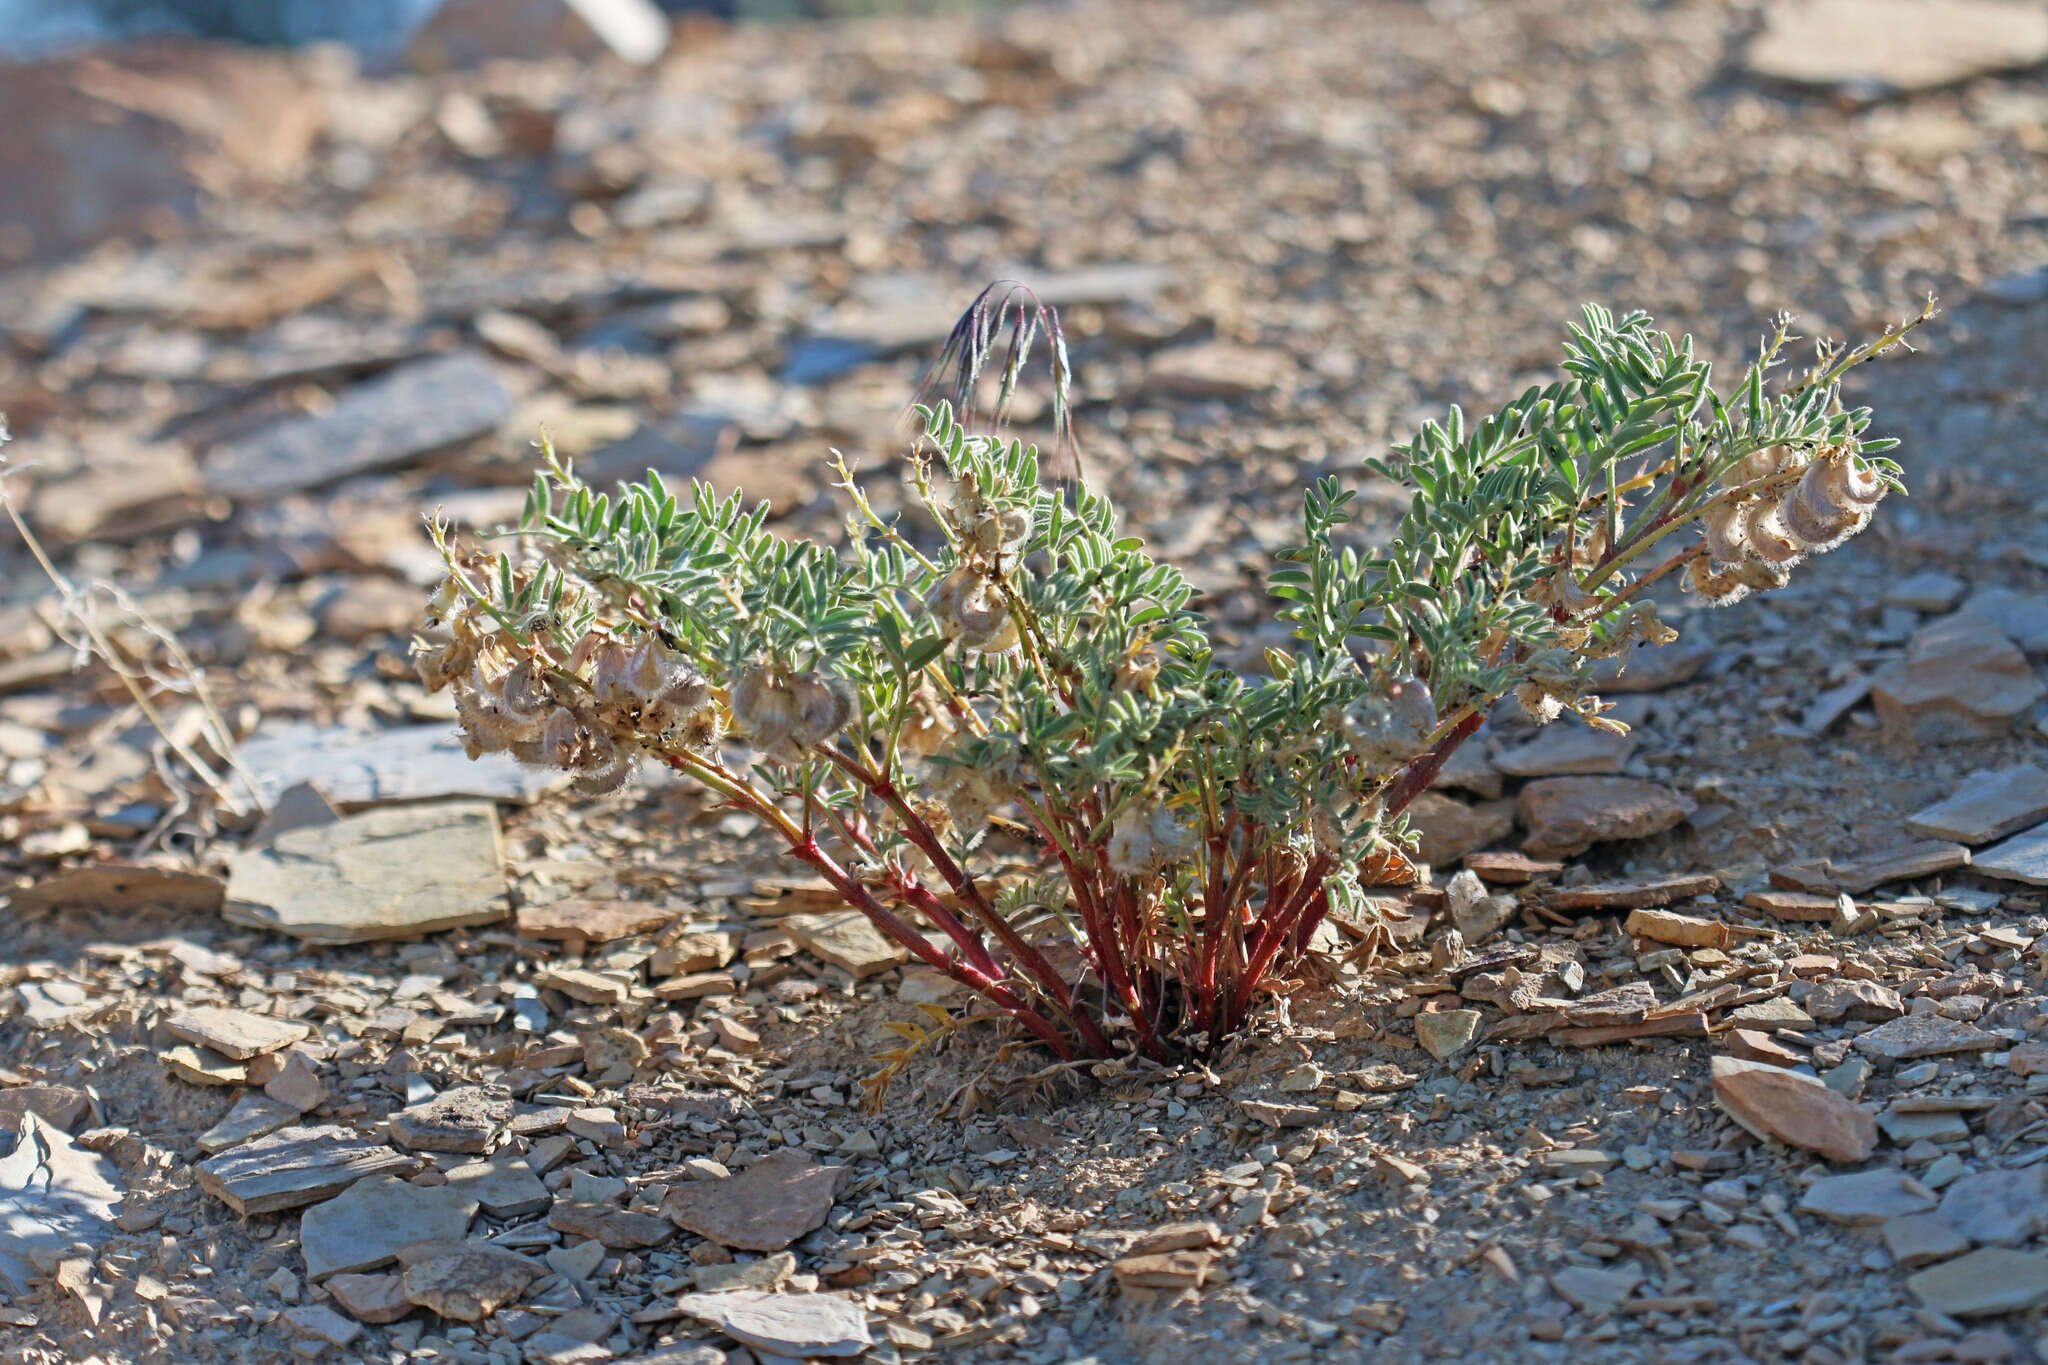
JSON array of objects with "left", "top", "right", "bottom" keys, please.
[{"left": 0, "top": 0, "right": 2048, "bottom": 1365}]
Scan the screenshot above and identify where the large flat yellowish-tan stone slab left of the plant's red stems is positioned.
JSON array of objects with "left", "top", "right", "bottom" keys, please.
[{"left": 223, "top": 800, "right": 506, "bottom": 943}]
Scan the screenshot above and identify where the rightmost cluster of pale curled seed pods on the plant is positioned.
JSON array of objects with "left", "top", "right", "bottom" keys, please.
[{"left": 1688, "top": 446, "right": 1886, "bottom": 606}]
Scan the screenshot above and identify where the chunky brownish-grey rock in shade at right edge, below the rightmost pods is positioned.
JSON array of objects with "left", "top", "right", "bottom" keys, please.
[{"left": 1870, "top": 614, "right": 2042, "bottom": 745}]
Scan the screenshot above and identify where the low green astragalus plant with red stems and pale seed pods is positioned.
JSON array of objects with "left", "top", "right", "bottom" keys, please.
[{"left": 418, "top": 307, "right": 1927, "bottom": 1060}]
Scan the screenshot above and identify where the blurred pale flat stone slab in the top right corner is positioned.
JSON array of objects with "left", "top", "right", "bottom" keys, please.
[{"left": 1745, "top": 0, "right": 2048, "bottom": 98}]
